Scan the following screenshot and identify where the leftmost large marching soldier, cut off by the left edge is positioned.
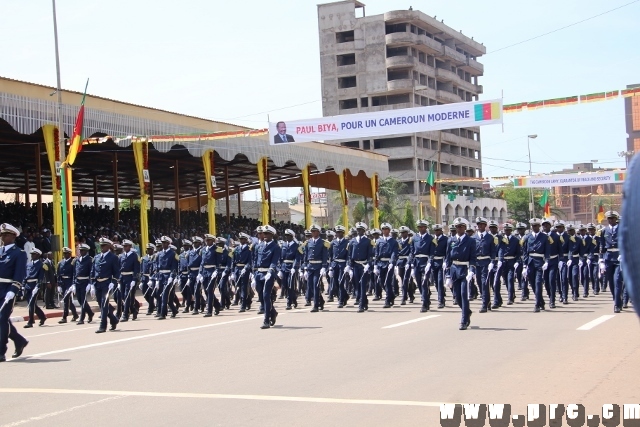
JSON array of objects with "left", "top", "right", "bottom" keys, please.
[{"left": 0, "top": 224, "right": 29, "bottom": 362}]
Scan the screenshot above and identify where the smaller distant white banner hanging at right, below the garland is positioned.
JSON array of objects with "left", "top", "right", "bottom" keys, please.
[{"left": 513, "top": 170, "right": 626, "bottom": 188}]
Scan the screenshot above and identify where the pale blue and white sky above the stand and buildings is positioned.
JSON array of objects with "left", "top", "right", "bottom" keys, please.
[{"left": 0, "top": 0, "right": 640, "bottom": 201}]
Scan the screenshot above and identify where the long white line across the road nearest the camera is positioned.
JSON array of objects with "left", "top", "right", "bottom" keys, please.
[{"left": 0, "top": 388, "right": 444, "bottom": 408}]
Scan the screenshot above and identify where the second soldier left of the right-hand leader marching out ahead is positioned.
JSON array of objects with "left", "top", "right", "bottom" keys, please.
[{"left": 410, "top": 219, "right": 435, "bottom": 313}]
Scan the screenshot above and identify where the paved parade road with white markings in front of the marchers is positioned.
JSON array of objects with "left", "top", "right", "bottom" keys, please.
[{"left": 0, "top": 293, "right": 640, "bottom": 427}]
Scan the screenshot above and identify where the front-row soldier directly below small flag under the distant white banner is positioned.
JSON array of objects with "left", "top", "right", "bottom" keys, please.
[{"left": 522, "top": 218, "right": 551, "bottom": 313}]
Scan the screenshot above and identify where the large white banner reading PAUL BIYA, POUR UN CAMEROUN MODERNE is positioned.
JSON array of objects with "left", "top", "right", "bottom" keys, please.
[{"left": 269, "top": 99, "right": 502, "bottom": 145}]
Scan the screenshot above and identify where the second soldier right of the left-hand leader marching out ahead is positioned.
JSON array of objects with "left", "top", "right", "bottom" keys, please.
[{"left": 304, "top": 224, "right": 329, "bottom": 313}]
